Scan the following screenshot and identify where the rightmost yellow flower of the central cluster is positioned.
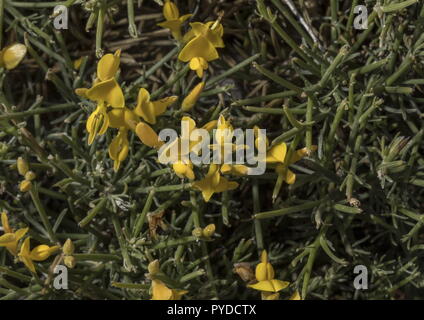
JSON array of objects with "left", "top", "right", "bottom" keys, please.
[{"left": 266, "top": 142, "right": 317, "bottom": 184}]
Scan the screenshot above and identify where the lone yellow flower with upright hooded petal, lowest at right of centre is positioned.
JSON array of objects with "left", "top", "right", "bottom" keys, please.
[{"left": 248, "top": 250, "right": 289, "bottom": 299}]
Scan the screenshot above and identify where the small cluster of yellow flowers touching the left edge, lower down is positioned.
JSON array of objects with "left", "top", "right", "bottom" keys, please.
[{"left": 0, "top": 212, "right": 59, "bottom": 273}]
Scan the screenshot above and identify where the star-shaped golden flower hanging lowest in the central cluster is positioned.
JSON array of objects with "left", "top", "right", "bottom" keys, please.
[{"left": 193, "top": 164, "right": 238, "bottom": 202}]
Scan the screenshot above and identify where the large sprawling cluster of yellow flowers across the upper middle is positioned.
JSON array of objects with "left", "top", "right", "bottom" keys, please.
[{"left": 76, "top": 1, "right": 307, "bottom": 202}]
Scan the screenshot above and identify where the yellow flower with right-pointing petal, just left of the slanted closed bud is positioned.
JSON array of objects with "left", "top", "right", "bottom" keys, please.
[{"left": 134, "top": 88, "right": 178, "bottom": 124}]
